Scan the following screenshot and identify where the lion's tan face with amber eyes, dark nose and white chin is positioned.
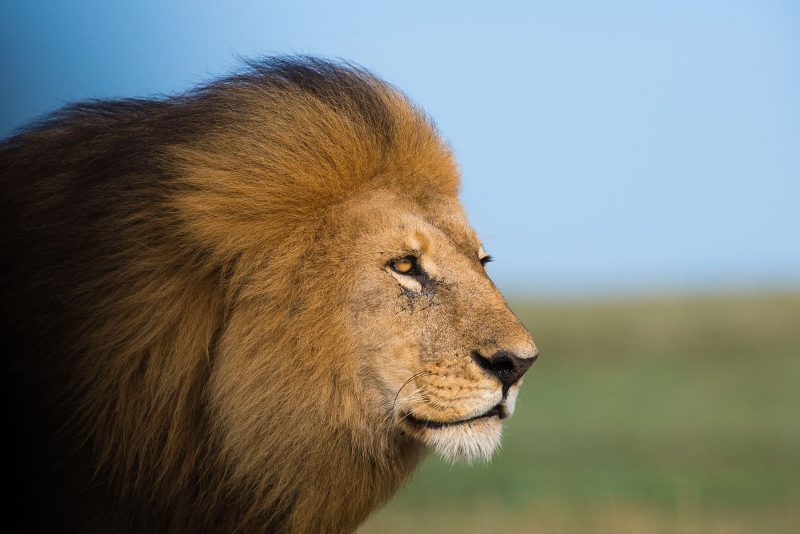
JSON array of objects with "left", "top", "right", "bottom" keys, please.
[{"left": 343, "top": 193, "right": 537, "bottom": 460}]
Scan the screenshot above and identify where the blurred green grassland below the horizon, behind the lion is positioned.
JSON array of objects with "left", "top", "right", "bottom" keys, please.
[{"left": 362, "top": 295, "right": 800, "bottom": 533}]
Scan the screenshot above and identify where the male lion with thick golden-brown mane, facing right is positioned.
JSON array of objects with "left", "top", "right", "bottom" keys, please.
[{"left": 0, "top": 57, "right": 538, "bottom": 532}]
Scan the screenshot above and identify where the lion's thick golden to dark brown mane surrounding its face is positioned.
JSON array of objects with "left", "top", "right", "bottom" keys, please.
[{"left": 0, "top": 57, "right": 458, "bottom": 532}]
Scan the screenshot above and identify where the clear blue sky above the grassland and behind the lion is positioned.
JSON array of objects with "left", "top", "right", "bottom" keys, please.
[{"left": 0, "top": 0, "right": 800, "bottom": 296}]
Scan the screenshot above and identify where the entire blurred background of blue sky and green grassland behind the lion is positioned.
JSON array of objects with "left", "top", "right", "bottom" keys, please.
[{"left": 0, "top": 0, "right": 800, "bottom": 533}]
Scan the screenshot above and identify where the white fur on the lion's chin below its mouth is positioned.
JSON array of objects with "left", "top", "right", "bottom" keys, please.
[{"left": 422, "top": 417, "right": 502, "bottom": 463}]
